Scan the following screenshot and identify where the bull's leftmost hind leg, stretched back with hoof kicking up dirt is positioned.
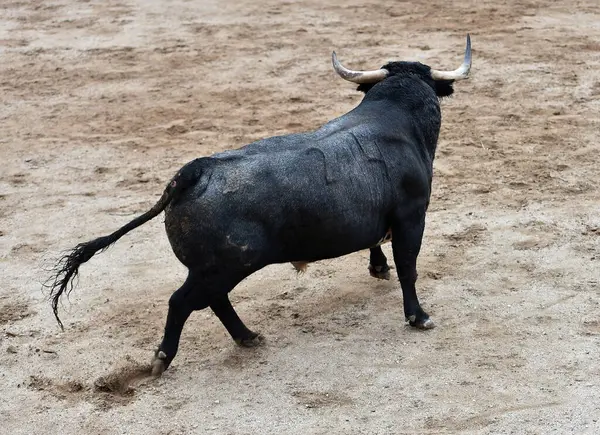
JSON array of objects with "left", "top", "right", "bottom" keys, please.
[{"left": 152, "top": 272, "right": 209, "bottom": 376}]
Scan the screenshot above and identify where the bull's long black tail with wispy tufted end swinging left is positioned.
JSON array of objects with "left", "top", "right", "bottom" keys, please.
[{"left": 44, "top": 159, "right": 201, "bottom": 329}]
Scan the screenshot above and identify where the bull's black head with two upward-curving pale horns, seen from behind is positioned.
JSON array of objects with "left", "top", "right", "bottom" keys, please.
[{"left": 331, "top": 35, "right": 471, "bottom": 96}]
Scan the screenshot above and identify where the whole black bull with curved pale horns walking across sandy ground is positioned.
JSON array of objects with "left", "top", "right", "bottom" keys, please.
[{"left": 50, "top": 39, "right": 470, "bottom": 374}]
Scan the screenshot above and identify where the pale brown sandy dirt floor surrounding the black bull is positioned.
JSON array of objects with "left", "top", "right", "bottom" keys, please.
[{"left": 0, "top": 0, "right": 600, "bottom": 435}]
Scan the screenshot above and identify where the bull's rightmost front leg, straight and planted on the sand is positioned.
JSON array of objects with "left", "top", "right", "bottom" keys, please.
[{"left": 392, "top": 209, "right": 435, "bottom": 329}]
